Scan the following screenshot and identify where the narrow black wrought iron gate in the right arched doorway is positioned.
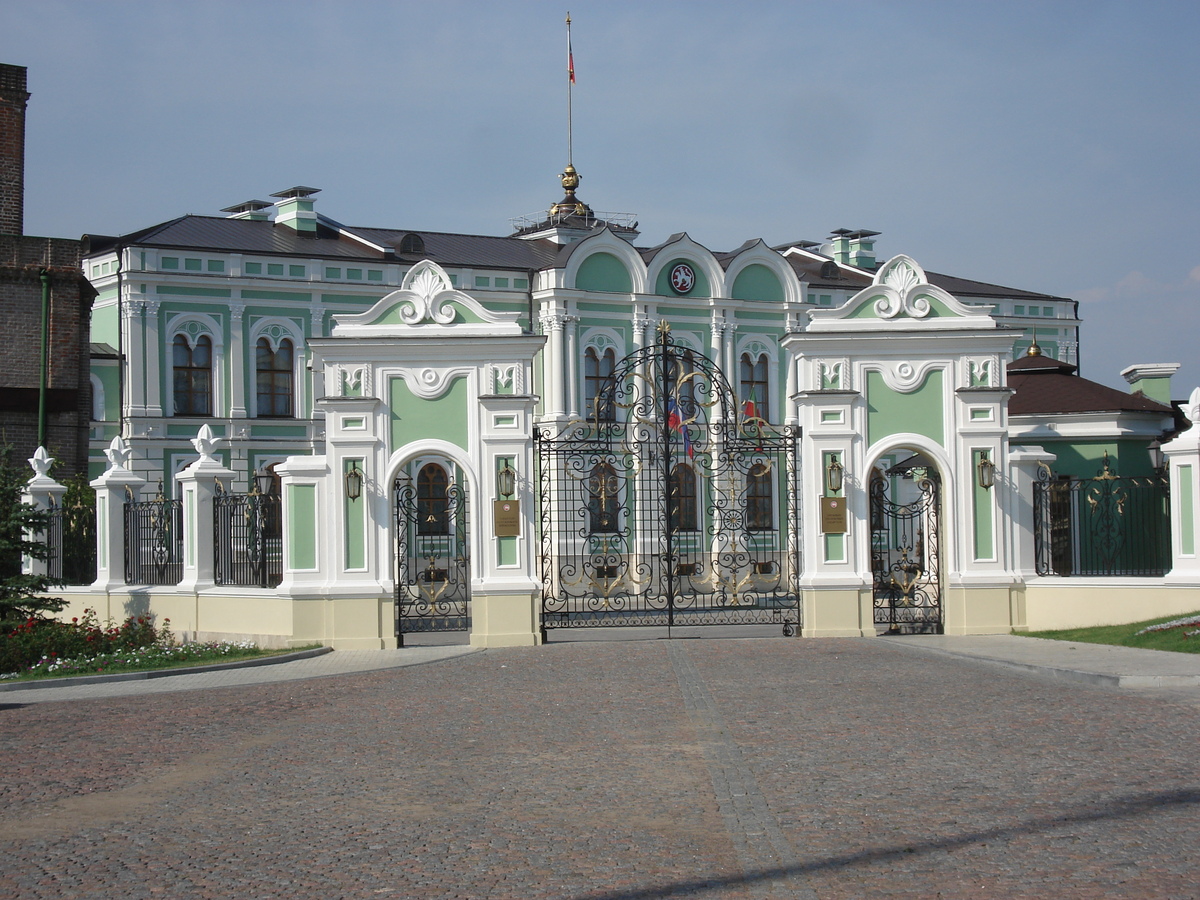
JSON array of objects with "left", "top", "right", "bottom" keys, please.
[{"left": 871, "top": 463, "right": 943, "bottom": 634}]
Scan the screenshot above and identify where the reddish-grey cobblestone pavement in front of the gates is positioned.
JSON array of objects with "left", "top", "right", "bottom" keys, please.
[{"left": 0, "top": 638, "right": 1200, "bottom": 900}]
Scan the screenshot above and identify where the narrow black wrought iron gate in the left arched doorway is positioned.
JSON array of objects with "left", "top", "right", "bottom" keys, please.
[{"left": 394, "top": 463, "right": 470, "bottom": 647}]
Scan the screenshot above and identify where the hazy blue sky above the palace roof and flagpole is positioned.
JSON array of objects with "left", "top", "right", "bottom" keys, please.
[{"left": 0, "top": 0, "right": 1200, "bottom": 398}]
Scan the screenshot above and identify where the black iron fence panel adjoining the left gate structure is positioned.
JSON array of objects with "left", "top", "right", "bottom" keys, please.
[{"left": 212, "top": 482, "right": 283, "bottom": 588}]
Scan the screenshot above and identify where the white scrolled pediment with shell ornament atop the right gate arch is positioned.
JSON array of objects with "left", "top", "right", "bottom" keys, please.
[{"left": 805, "top": 254, "right": 996, "bottom": 331}]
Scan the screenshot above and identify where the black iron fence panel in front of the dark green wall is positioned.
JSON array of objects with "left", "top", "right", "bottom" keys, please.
[{"left": 1033, "top": 455, "right": 1171, "bottom": 576}]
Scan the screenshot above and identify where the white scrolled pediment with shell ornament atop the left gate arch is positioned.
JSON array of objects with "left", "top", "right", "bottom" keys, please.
[{"left": 332, "top": 259, "right": 521, "bottom": 337}]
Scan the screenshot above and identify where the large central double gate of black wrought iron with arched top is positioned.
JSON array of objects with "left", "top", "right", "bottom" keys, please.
[{"left": 534, "top": 328, "right": 800, "bottom": 637}]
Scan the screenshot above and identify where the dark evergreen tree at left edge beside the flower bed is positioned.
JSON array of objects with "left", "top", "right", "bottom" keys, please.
[{"left": 0, "top": 446, "right": 66, "bottom": 631}]
